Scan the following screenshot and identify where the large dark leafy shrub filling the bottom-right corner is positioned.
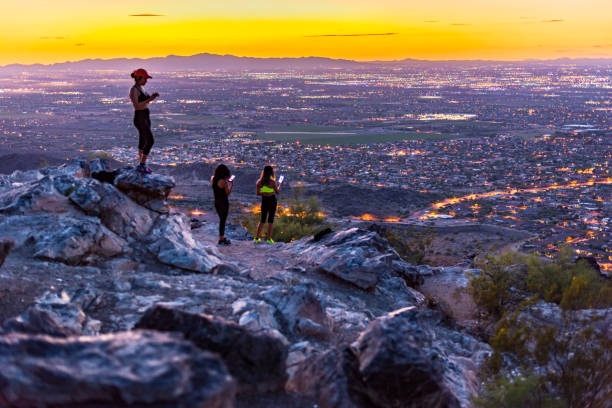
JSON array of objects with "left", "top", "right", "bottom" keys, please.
[{"left": 476, "top": 310, "right": 612, "bottom": 408}]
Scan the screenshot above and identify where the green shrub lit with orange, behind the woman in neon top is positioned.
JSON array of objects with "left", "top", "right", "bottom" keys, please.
[{"left": 241, "top": 192, "right": 329, "bottom": 242}]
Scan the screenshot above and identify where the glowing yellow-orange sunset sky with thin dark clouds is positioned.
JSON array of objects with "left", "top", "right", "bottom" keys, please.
[{"left": 0, "top": 0, "right": 612, "bottom": 65}]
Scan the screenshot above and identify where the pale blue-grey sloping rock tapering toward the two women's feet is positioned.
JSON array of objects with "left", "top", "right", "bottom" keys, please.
[{"left": 148, "top": 214, "right": 233, "bottom": 273}]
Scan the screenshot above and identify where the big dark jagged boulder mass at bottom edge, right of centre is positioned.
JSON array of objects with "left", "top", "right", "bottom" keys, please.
[{"left": 287, "top": 307, "right": 490, "bottom": 407}]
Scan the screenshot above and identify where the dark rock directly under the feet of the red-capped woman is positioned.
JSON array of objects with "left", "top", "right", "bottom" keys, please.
[{"left": 114, "top": 167, "right": 176, "bottom": 214}]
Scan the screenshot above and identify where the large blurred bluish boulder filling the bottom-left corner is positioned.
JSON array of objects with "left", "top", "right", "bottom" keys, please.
[{"left": 0, "top": 331, "right": 235, "bottom": 408}]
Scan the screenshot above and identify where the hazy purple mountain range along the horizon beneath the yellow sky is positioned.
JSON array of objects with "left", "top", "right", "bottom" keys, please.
[{"left": 0, "top": 53, "right": 612, "bottom": 74}]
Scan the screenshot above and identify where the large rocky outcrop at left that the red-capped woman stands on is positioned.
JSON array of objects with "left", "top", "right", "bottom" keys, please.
[{"left": 0, "top": 159, "right": 233, "bottom": 272}]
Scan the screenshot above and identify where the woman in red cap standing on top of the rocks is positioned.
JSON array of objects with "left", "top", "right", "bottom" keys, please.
[{"left": 130, "top": 68, "right": 159, "bottom": 174}]
